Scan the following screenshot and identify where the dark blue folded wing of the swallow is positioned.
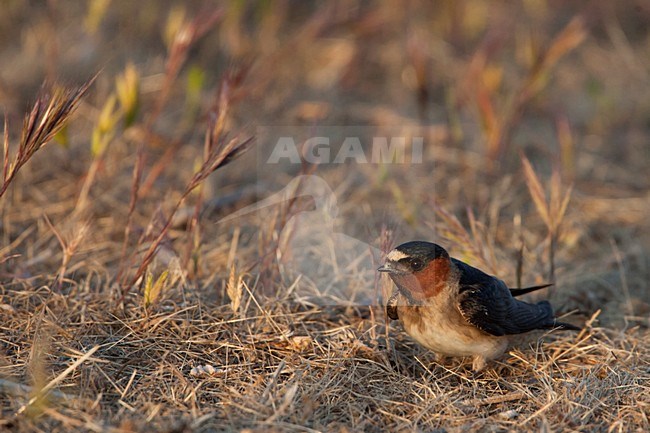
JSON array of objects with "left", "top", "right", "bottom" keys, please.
[{"left": 452, "top": 259, "right": 555, "bottom": 336}]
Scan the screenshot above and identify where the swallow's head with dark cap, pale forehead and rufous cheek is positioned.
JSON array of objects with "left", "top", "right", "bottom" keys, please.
[{"left": 377, "top": 241, "right": 451, "bottom": 304}]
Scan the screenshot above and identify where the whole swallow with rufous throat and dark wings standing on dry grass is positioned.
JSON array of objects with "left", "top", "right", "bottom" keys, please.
[{"left": 378, "top": 241, "right": 580, "bottom": 371}]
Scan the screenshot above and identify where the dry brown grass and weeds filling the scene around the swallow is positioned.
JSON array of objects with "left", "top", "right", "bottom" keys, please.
[{"left": 0, "top": 0, "right": 650, "bottom": 433}]
